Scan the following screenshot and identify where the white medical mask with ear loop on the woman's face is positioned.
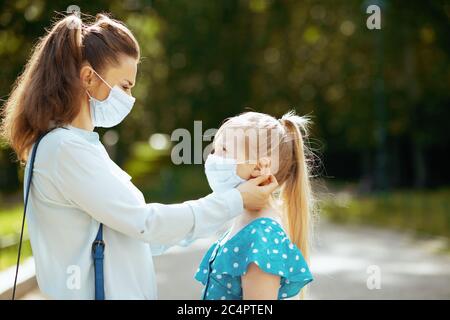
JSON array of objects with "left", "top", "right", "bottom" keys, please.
[{"left": 86, "top": 69, "right": 136, "bottom": 128}]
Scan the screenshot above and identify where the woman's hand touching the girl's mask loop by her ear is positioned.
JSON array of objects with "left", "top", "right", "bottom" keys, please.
[{"left": 237, "top": 175, "right": 278, "bottom": 211}]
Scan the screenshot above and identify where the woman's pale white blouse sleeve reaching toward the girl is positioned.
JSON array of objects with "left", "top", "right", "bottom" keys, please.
[{"left": 55, "top": 140, "right": 243, "bottom": 245}]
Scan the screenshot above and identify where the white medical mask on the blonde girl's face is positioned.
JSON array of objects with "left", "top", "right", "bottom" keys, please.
[{"left": 205, "top": 154, "right": 246, "bottom": 192}]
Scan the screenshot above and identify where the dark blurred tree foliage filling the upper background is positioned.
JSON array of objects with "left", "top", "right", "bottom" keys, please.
[{"left": 0, "top": 0, "right": 450, "bottom": 195}]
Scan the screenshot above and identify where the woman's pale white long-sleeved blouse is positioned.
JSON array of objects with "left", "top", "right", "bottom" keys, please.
[{"left": 24, "top": 126, "right": 243, "bottom": 299}]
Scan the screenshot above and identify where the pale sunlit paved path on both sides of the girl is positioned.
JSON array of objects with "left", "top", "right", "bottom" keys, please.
[{"left": 18, "top": 222, "right": 450, "bottom": 299}]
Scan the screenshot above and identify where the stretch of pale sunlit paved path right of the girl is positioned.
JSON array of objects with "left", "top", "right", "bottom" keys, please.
[{"left": 310, "top": 220, "right": 450, "bottom": 299}]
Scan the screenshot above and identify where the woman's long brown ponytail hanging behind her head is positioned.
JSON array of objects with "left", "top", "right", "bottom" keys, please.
[{"left": 1, "top": 15, "right": 83, "bottom": 161}]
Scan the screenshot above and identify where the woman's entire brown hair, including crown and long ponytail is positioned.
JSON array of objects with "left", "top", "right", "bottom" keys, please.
[{"left": 1, "top": 14, "right": 140, "bottom": 161}]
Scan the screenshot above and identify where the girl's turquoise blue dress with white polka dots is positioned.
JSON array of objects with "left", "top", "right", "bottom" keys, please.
[{"left": 195, "top": 217, "right": 313, "bottom": 300}]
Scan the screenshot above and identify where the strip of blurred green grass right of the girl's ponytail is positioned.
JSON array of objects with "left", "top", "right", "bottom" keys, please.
[{"left": 322, "top": 188, "right": 450, "bottom": 238}]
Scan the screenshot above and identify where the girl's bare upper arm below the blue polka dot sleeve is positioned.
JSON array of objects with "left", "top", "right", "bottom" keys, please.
[{"left": 241, "top": 263, "right": 280, "bottom": 300}]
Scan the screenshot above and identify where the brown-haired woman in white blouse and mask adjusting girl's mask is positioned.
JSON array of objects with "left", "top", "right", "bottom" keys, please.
[{"left": 2, "top": 15, "right": 276, "bottom": 299}]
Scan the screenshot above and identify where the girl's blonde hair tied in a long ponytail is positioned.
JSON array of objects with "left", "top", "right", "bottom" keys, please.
[{"left": 216, "top": 111, "right": 314, "bottom": 298}]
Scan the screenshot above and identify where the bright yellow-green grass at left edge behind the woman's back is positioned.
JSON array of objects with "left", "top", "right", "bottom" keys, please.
[{"left": 0, "top": 205, "right": 32, "bottom": 270}]
